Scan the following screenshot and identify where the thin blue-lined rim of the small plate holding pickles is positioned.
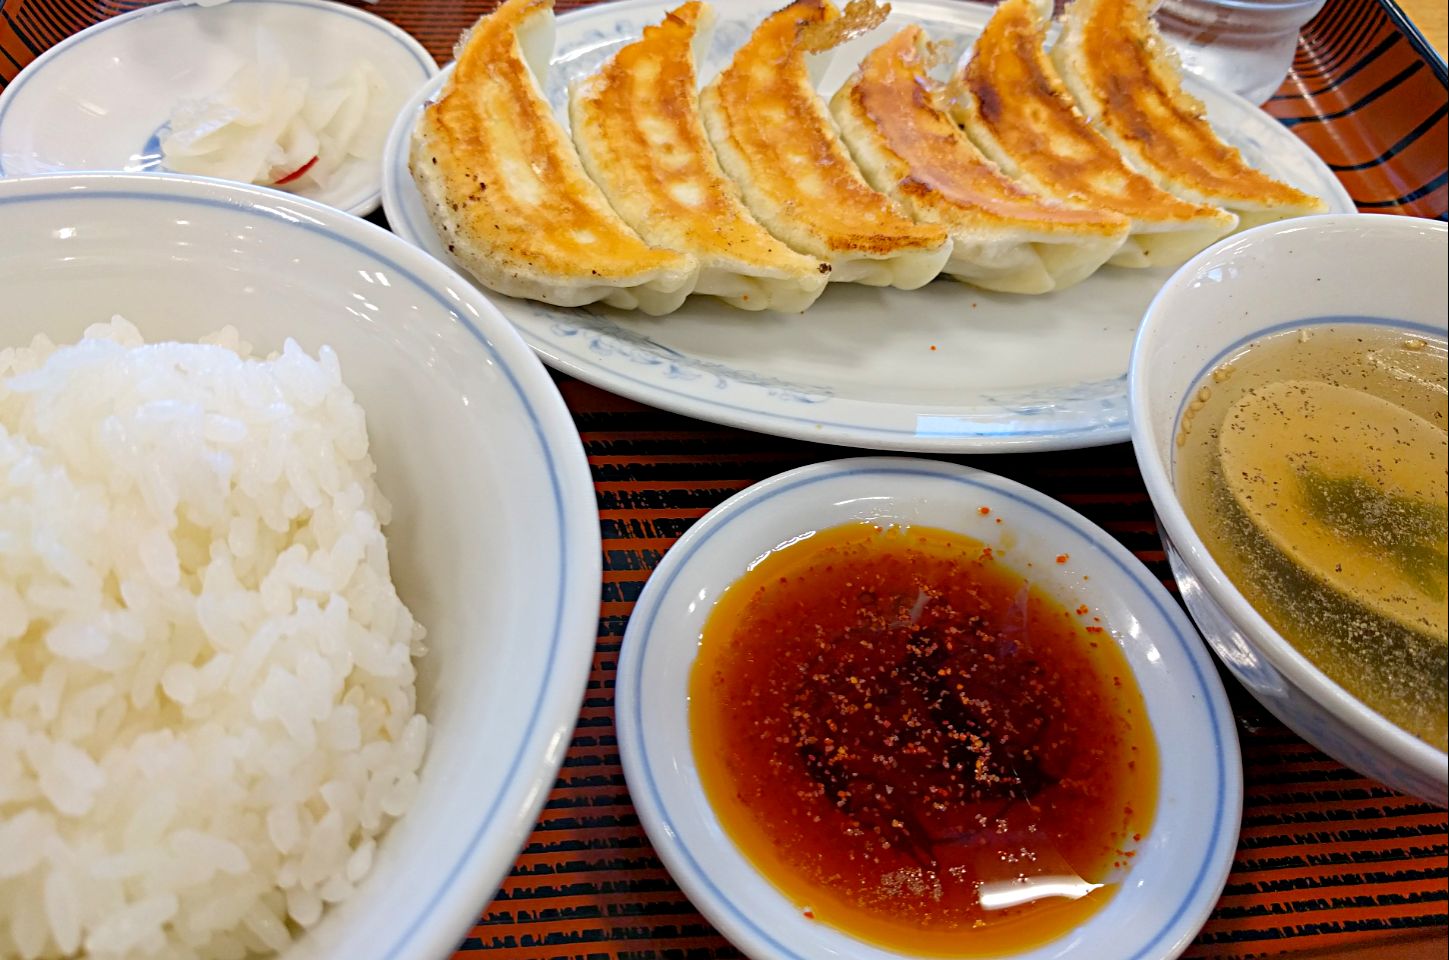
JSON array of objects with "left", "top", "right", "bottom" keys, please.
[{"left": 0, "top": 0, "right": 438, "bottom": 216}]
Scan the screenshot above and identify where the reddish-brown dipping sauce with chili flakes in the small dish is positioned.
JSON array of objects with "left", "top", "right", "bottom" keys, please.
[{"left": 690, "top": 524, "right": 1158, "bottom": 956}]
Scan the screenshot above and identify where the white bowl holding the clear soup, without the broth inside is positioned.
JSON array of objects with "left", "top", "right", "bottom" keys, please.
[{"left": 1129, "top": 216, "right": 1449, "bottom": 807}]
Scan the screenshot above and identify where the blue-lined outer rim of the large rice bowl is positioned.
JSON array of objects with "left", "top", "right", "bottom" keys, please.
[{"left": 0, "top": 173, "right": 600, "bottom": 960}]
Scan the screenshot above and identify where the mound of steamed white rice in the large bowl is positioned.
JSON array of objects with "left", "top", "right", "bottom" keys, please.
[{"left": 0, "top": 317, "right": 427, "bottom": 960}]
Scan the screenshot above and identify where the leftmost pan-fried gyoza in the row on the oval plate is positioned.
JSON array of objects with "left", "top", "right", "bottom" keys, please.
[{"left": 410, "top": 0, "right": 697, "bottom": 313}]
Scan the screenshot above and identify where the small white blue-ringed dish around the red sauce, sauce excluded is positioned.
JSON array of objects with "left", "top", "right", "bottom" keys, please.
[{"left": 614, "top": 458, "right": 1242, "bottom": 960}]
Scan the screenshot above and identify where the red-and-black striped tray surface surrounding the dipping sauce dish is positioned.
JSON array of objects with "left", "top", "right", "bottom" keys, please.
[{"left": 489, "top": 378, "right": 1449, "bottom": 960}]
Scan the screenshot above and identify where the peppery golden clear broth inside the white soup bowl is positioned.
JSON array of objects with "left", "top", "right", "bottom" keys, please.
[{"left": 1174, "top": 324, "right": 1449, "bottom": 750}]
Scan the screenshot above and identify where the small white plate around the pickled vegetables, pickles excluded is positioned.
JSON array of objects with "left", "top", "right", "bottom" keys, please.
[{"left": 0, "top": 0, "right": 438, "bottom": 216}]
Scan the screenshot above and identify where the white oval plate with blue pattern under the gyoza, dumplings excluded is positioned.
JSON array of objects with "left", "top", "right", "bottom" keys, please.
[{"left": 383, "top": 0, "right": 1353, "bottom": 452}]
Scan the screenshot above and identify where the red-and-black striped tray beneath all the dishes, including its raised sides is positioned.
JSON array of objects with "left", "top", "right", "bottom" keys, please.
[{"left": 0, "top": 0, "right": 1449, "bottom": 960}]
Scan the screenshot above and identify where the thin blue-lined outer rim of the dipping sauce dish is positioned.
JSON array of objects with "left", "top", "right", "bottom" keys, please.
[{"left": 616, "top": 458, "right": 1242, "bottom": 960}]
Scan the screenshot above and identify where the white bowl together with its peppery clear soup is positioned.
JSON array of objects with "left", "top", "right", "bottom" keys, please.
[{"left": 1127, "top": 214, "right": 1449, "bottom": 805}]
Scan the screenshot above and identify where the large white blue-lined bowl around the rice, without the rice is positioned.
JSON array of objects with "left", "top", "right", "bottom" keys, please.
[{"left": 0, "top": 173, "right": 600, "bottom": 960}]
